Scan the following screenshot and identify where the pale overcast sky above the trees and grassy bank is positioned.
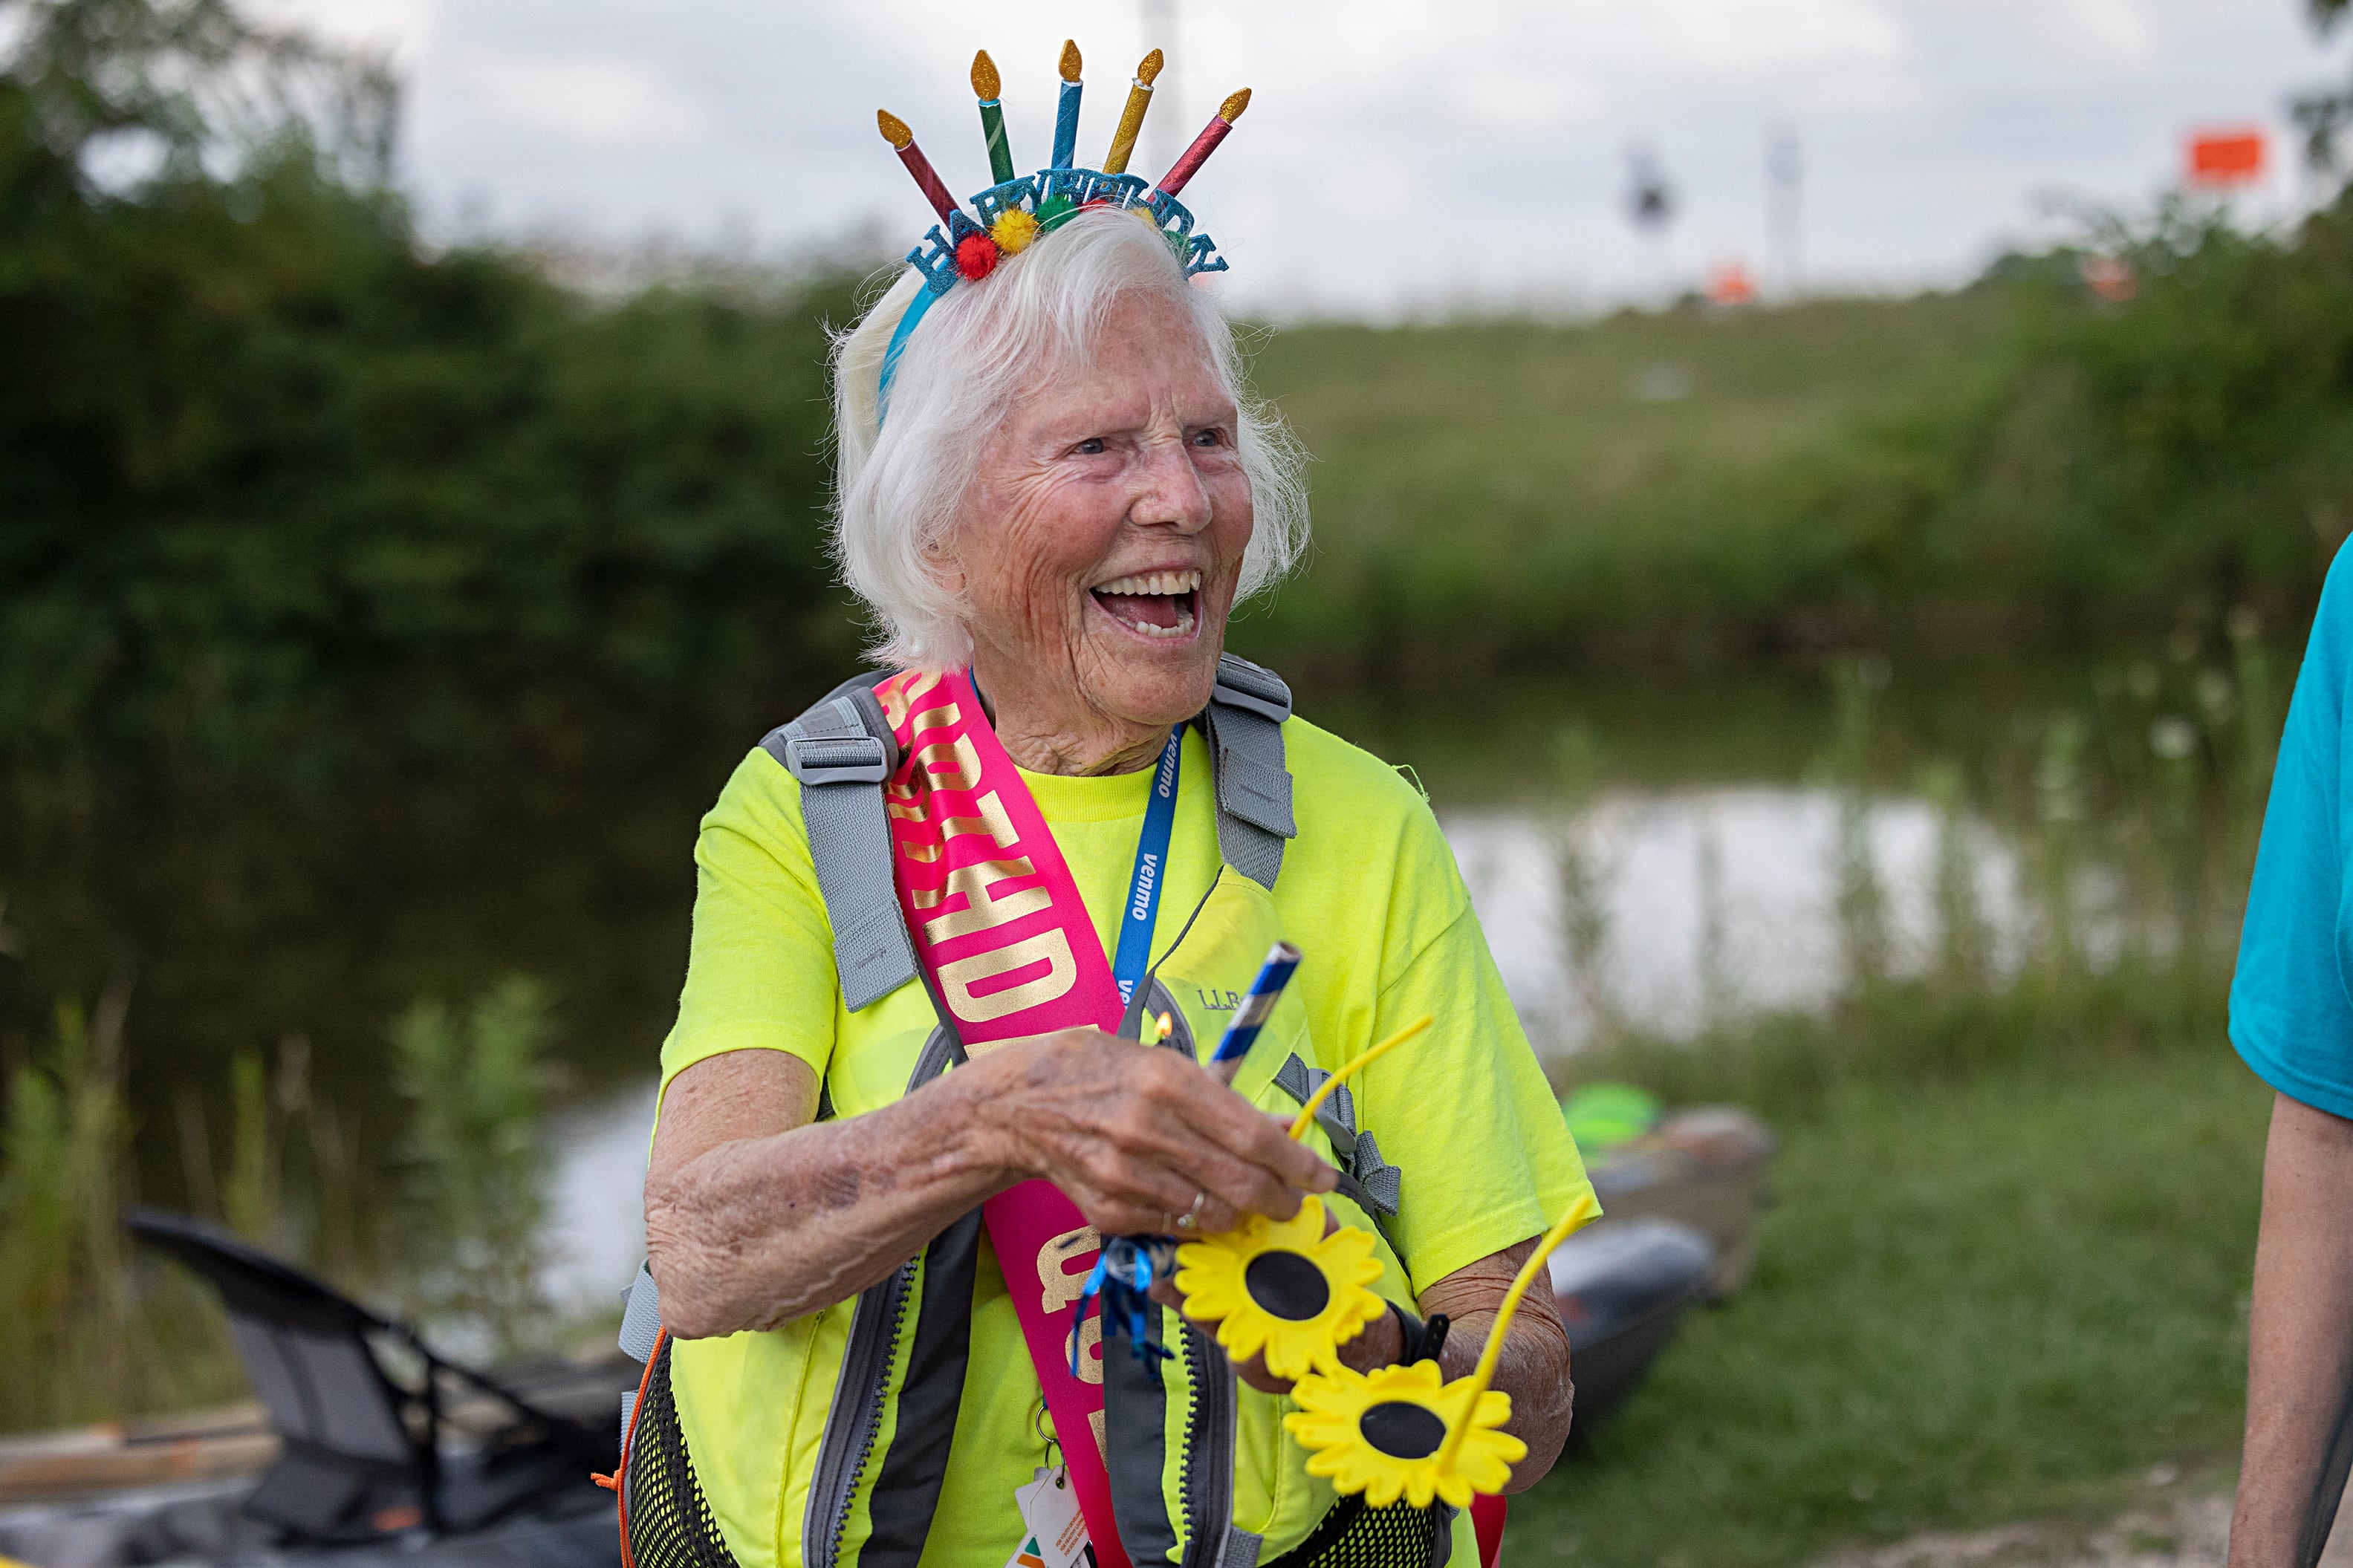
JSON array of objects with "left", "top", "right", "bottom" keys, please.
[{"left": 276, "top": 0, "right": 2353, "bottom": 315}]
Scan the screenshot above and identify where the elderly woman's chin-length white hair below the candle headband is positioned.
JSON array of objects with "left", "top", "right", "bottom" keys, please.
[{"left": 833, "top": 209, "right": 1308, "bottom": 670}]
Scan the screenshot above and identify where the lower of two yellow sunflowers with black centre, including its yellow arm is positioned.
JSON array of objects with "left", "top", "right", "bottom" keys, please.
[{"left": 1282, "top": 1199, "right": 1595, "bottom": 1509}]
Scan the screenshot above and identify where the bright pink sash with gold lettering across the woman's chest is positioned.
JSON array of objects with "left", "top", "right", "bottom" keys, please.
[{"left": 875, "top": 670, "right": 1129, "bottom": 1568}]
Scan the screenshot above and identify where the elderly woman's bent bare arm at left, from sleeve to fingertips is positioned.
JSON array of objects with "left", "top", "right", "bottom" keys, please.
[{"left": 645, "top": 1029, "right": 1337, "bottom": 1340}]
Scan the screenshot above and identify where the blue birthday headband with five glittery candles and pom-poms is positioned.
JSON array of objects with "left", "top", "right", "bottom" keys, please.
[{"left": 875, "top": 40, "right": 1250, "bottom": 409}]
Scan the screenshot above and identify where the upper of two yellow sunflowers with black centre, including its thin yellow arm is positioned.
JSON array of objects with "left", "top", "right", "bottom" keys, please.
[{"left": 1177, "top": 1015, "right": 1431, "bottom": 1380}]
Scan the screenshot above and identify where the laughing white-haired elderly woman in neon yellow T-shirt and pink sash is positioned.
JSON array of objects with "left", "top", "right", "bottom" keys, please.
[{"left": 623, "top": 209, "right": 1591, "bottom": 1568}]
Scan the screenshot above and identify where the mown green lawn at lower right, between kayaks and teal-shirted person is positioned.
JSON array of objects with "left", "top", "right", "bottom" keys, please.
[{"left": 1508, "top": 1001, "right": 2271, "bottom": 1568}]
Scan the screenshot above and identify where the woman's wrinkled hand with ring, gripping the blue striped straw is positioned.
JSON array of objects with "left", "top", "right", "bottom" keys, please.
[{"left": 972, "top": 1029, "right": 1337, "bottom": 1237}]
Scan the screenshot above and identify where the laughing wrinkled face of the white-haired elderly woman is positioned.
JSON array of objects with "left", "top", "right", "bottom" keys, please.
[{"left": 936, "top": 294, "right": 1252, "bottom": 773}]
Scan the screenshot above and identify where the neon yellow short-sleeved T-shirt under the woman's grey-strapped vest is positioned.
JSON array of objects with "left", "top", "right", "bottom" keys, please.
[{"left": 661, "top": 717, "right": 1591, "bottom": 1568}]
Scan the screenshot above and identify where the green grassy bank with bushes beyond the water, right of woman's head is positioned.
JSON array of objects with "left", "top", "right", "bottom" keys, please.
[{"left": 1236, "top": 202, "right": 2353, "bottom": 682}]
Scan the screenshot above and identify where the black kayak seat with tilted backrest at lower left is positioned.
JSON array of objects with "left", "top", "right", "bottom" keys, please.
[{"left": 123, "top": 1208, "right": 609, "bottom": 1542}]
